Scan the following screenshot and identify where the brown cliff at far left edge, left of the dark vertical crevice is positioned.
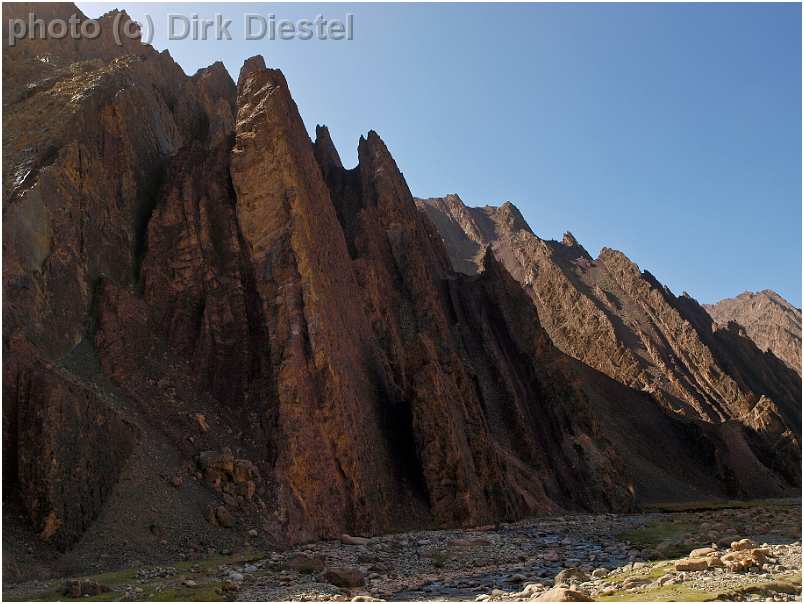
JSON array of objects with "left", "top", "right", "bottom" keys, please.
[{"left": 3, "top": 4, "right": 248, "bottom": 548}]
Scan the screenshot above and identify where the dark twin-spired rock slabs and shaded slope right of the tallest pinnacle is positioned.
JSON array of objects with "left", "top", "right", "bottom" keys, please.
[{"left": 314, "top": 127, "right": 786, "bottom": 522}]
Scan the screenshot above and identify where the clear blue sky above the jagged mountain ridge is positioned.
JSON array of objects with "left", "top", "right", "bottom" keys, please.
[{"left": 79, "top": 2, "right": 802, "bottom": 306}]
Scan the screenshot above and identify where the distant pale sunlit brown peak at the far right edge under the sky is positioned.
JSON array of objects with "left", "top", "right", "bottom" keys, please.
[{"left": 704, "top": 289, "right": 801, "bottom": 375}]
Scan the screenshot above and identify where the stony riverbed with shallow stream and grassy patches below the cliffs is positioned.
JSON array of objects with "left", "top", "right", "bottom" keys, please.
[{"left": 3, "top": 501, "right": 801, "bottom": 601}]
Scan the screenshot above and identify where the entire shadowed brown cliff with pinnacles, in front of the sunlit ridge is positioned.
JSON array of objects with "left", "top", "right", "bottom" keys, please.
[{"left": 3, "top": 1, "right": 795, "bottom": 560}]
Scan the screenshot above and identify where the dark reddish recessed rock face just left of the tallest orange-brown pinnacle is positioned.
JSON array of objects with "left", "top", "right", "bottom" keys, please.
[{"left": 141, "top": 138, "right": 264, "bottom": 403}]
